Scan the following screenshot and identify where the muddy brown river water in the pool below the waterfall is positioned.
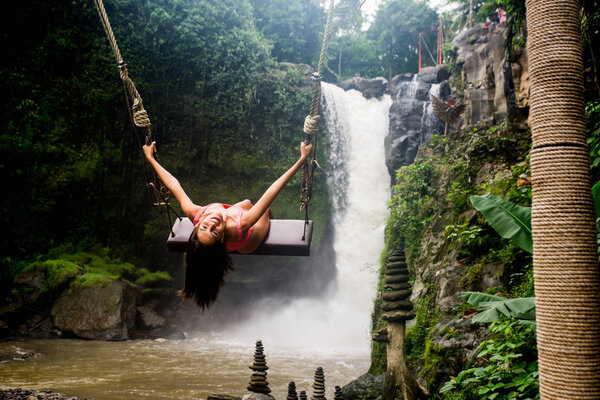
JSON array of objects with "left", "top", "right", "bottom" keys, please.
[{"left": 0, "top": 337, "right": 369, "bottom": 400}]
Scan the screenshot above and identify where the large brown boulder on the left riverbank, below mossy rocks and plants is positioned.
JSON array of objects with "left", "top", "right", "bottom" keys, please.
[{"left": 51, "top": 281, "right": 141, "bottom": 340}]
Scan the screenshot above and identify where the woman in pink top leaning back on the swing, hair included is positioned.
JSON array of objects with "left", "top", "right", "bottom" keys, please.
[{"left": 144, "top": 142, "right": 312, "bottom": 309}]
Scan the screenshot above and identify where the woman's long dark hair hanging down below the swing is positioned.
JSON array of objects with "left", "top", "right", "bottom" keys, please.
[{"left": 179, "top": 229, "right": 233, "bottom": 310}]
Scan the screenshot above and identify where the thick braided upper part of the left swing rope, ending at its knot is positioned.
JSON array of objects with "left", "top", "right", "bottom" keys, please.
[{"left": 94, "top": 0, "right": 150, "bottom": 128}]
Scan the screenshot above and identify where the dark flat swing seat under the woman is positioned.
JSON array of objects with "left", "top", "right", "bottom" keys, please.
[{"left": 167, "top": 218, "right": 313, "bottom": 256}]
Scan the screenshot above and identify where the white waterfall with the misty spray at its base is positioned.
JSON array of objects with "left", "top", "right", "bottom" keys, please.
[{"left": 220, "top": 83, "right": 392, "bottom": 354}]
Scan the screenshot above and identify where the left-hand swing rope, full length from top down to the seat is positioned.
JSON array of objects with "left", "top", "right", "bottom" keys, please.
[{"left": 94, "top": 0, "right": 181, "bottom": 236}]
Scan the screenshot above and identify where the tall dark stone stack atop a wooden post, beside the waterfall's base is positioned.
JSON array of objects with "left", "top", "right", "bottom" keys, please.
[{"left": 381, "top": 249, "right": 415, "bottom": 322}]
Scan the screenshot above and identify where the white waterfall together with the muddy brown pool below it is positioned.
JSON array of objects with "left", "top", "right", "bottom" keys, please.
[{"left": 0, "top": 84, "right": 391, "bottom": 400}]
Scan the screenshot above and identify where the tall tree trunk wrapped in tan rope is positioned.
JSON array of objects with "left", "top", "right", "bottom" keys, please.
[{"left": 527, "top": 0, "right": 600, "bottom": 399}]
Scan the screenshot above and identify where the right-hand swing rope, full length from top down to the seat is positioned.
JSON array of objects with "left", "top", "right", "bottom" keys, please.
[{"left": 300, "top": 0, "right": 334, "bottom": 240}]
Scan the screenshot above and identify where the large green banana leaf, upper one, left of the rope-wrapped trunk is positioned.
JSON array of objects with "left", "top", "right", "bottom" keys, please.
[{"left": 471, "top": 194, "right": 533, "bottom": 254}]
